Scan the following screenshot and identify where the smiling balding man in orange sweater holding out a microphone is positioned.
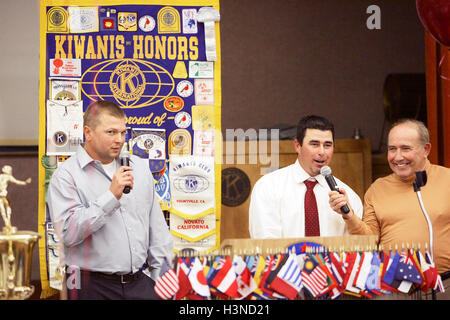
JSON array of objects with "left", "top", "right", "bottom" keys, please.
[{"left": 330, "top": 119, "right": 450, "bottom": 299}]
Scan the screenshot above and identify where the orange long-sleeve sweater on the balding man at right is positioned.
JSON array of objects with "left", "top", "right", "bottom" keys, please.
[{"left": 346, "top": 161, "right": 450, "bottom": 273}]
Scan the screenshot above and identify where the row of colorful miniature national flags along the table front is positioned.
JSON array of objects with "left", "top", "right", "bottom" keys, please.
[{"left": 155, "top": 249, "right": 444, "bottom": 300}]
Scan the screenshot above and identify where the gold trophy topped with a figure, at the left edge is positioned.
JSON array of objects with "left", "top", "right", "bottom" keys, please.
[{"left": 0, "top": 165, "right": 41, "bottom": 300}]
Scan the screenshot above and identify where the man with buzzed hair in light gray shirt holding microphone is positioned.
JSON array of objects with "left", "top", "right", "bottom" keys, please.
[{"left": 48, "top": 101, "right": 173, "bottom": 299}]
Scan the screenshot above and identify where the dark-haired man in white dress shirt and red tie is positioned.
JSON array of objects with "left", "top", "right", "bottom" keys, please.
[{"left": 249, "top": 115, "right": 363, "bottom": 239}]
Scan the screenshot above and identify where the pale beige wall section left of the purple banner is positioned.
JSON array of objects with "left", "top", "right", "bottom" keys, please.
[{"left": 0, "top": 0, "right": 39, "bottom": 142}]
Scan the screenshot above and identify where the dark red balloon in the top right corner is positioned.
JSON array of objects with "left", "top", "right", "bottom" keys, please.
[{"left": 416, "top": 0, "right": 450, "bottom": 46}]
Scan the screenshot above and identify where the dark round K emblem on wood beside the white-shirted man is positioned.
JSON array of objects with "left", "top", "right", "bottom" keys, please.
[{"left": 222, "top": 168, "right": 251, "bottom": 207}]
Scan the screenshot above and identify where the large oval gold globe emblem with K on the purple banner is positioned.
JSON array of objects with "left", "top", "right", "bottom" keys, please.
[{"left": 81, "top": 59, "right": 175, "bottom": 108}]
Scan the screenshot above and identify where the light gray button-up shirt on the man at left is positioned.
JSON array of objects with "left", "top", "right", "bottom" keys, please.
[{"left": 48, "top": 147, "right": 173, "bottom": 279}]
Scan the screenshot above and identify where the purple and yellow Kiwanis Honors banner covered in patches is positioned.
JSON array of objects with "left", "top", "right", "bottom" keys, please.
[{"left": 39, "top": 0, "right": 221, "bottom": 296}]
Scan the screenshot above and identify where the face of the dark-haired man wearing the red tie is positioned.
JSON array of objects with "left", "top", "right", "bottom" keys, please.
[{"left": 294, "top": 129, "right": 334, "bottom": 176}]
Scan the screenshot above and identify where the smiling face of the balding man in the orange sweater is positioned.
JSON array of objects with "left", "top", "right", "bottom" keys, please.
[{"left": 387, "top": 123, "right": 431, "bottom": 181}]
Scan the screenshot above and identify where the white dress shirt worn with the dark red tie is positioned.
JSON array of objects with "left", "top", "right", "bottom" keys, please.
[{"left": 249, "top": 160, "right": 363, "bottom": 239}]
